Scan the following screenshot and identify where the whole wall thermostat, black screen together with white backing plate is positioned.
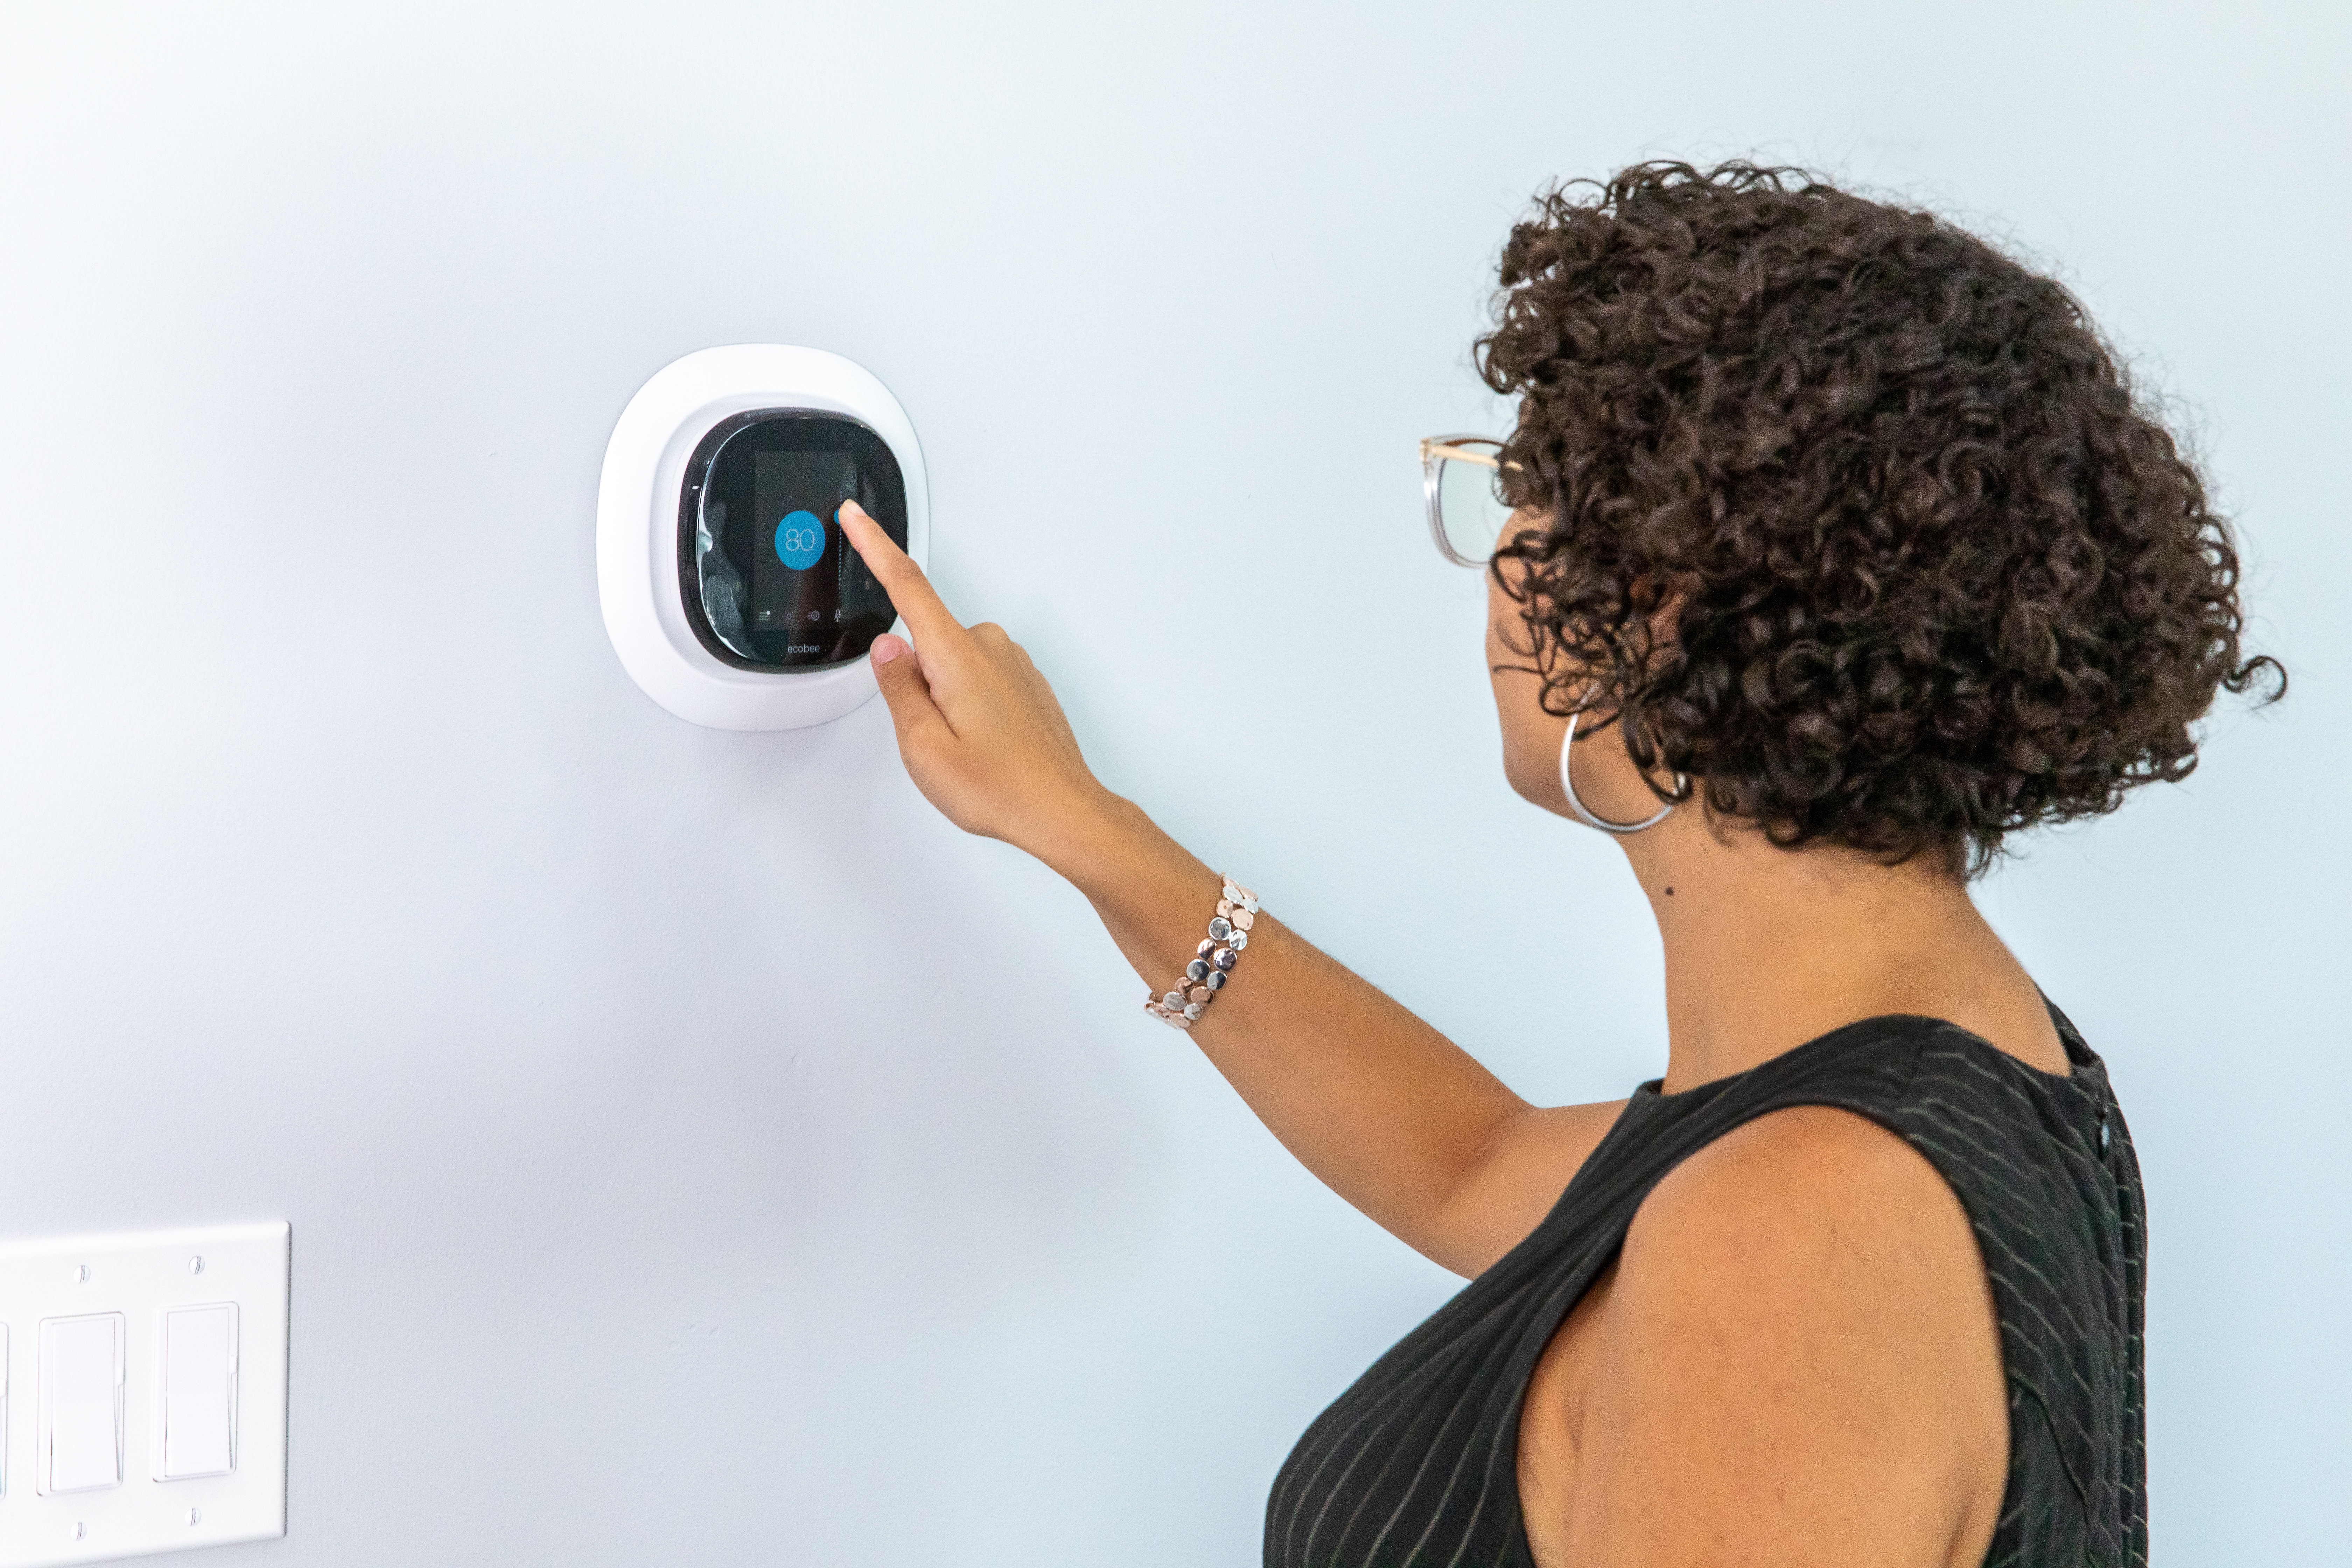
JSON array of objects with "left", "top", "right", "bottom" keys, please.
[{"left": 595, "top": 343, "right": 931, "bottom": 729}]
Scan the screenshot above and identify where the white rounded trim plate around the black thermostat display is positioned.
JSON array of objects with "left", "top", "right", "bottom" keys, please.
[{"left": 595, "top": 343, "right": 931, "bottom": 729}]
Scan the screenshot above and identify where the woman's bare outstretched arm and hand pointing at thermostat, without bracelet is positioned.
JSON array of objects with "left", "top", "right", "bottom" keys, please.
[{"left": 840, "top": 503, "right": 1616, "bottom": 1274}]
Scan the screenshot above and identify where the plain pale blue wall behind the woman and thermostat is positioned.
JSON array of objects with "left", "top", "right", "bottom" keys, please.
[{"left": 0, "top": 0, "right": 2352, "bottom": 1568}]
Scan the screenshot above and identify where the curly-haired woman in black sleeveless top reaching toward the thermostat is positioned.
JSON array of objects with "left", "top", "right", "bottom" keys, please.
[{"left": 842, "top": 164, "right": 2277, "bottom": 1568}]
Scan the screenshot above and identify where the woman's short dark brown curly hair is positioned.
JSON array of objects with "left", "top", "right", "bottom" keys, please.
[{"left": 1477, "top": 162, "right": 2284, "bottom": 875}]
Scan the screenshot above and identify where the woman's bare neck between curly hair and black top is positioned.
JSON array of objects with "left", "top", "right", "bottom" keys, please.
[{"left": 1620, "top": 806, "right": 2067, "bottom": 1093}]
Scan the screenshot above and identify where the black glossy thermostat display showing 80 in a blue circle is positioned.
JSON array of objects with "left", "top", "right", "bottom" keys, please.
[{"left": 677, "top": 411, "right": 905, "bottom": 670}]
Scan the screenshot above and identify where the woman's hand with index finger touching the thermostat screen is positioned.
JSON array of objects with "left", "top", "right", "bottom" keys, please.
[{"left": 837, "top": 501, "right": 1113, "bottom": 867}]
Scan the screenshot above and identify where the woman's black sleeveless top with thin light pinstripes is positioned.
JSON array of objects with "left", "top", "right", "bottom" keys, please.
[{"left": 1265, "top": 1008, "right": 2147, "bottom": 1568}]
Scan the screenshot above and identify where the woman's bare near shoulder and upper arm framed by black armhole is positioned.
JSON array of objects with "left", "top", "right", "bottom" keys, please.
[{"left": 1574, "top": 1107, "right": 2009, "bottom": 1568}]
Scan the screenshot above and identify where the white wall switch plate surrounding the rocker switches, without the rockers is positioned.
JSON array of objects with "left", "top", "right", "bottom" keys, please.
[{"left": 0, "top": 1223, "right": 289, "bottom": 1568}]
